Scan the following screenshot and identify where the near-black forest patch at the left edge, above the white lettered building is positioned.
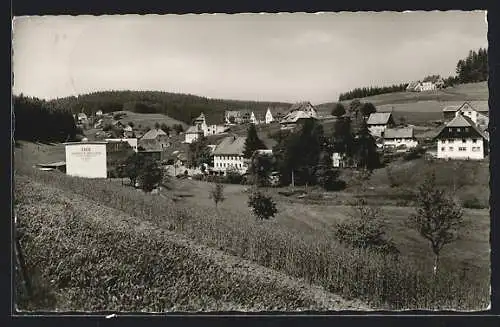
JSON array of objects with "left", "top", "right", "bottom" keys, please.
[{"left": 13, "top": 94, "right": 78, "bottom": 142}]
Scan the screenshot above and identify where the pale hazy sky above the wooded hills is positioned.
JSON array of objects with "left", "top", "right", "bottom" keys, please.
[{"left": 13, "top": 11, "right": 488, "bottom": 104}]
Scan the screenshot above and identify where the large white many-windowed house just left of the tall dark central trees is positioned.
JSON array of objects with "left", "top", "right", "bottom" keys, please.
[{"left": 213, "top": 136, "right": 248, "bottom": 174}]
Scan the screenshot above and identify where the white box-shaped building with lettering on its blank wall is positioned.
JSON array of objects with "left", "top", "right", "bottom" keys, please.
[{"left": 64, "top": 141, "right": 132, "bottom": 178}]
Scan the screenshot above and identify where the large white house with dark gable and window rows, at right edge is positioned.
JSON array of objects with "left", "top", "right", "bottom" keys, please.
[{"left": 435, "top": 113, "right": 489, "bottom": 160}]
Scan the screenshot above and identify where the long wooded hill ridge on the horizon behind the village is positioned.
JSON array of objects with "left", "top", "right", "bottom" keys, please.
[{"left": 37, "top": 91, "right": 289, "bottom": 124}]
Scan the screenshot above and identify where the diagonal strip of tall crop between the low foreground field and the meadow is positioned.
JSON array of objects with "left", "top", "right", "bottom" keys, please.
[{"left": 14, "top": 170, "right": 490, "bottom": 310}]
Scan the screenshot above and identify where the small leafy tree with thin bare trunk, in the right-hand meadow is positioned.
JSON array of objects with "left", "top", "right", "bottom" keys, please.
[{"left": 408, "top": 173, "right": 463, "bottom": 275}]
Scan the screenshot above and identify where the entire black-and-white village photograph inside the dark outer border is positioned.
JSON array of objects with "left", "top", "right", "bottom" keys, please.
[{"left": 11, "top": 10, "right": 491, "bottom": 315}]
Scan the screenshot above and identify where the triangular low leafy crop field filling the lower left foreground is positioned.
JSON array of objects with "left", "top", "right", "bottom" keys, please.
[{"left": 16, "top": 178, "right": 368, "bottom": 312}]
